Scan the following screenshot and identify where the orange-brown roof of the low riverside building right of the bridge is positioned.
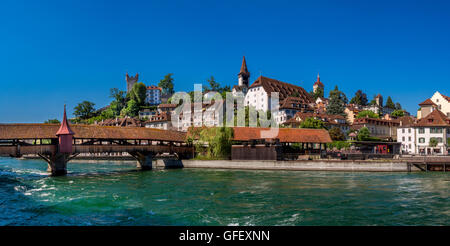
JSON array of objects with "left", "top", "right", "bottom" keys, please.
[{"left": 233, "top": 127, "right": 332, "bottom": 143}]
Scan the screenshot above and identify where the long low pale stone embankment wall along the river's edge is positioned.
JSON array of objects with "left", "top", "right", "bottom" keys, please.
[{"left": 153, "top": 160, "right": 420, "bottom": 172}]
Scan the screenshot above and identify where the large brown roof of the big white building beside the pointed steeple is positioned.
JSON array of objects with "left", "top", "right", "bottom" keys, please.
[{"left": 249, "top": 76, "right": 314, "bottom": 103}]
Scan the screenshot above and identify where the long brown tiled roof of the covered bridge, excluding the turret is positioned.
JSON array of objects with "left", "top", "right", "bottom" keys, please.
[{"left": 0, "top": 124, "right": 186, "bottom": 142}]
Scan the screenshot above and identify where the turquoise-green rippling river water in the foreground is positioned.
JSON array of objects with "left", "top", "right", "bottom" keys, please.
[{"left": 0, "top": 158, "right": 450, "bottom": 225}]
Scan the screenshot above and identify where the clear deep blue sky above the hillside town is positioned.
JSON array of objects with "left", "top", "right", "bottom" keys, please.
[{"left": 0, "top": 0, "right": 450, "bottom": 122}]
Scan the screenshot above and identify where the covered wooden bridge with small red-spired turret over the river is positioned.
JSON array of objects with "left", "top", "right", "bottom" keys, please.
[{"left": 0, "top": 107, "right": 193, "bottom": 175}]
